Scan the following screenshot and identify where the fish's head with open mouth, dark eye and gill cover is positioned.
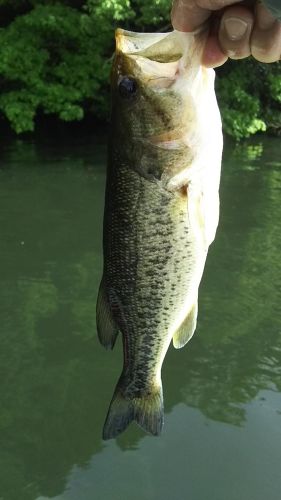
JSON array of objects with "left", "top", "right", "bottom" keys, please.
[{"left": 111, "top": 29, "right": 222, "bottom": 187}]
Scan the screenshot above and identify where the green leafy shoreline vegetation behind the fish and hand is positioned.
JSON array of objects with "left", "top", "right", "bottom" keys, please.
[{"left": 0, "top": 0, "right": 281, "bottom": 140}]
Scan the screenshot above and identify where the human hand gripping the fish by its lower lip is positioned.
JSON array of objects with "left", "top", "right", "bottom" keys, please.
[{"left": 171, "top": 0, "right": 281, "bottom": 68}]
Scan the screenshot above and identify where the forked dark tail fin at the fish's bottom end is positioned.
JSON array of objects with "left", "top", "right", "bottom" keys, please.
[{"left": 103, "top": 385, "right": 164, "bottom": 439}]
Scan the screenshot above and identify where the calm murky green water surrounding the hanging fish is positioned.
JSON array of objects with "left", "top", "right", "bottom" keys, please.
[{"left": 0, "top": 138, "right": 281, "bottom": 500}]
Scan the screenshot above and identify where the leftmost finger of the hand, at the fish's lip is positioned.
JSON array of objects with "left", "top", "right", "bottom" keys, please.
[{"left": 171, "top": 0, "right": 242, "bottom": 31}]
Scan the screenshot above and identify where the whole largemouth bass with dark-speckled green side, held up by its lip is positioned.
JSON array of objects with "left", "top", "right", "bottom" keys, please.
[{"left": 96, "top": 29, "right": 223, "bottom": 440}]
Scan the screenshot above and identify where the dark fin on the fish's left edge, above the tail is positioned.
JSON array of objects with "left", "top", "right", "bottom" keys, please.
[{"left": 96, "top": 278, "right": 118, "bottom": 349}]
